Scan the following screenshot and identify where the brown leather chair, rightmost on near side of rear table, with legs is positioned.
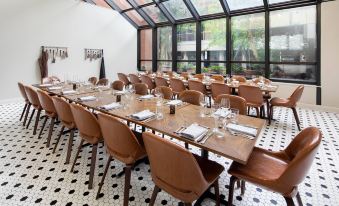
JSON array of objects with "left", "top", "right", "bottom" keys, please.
[{"left": 238, "top": 85, "right": 265, "bottom": 117}]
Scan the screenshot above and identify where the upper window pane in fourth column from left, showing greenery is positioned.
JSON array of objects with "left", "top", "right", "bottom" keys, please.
[{"left": 201, "top": 19, "right": 226, "bottom": 61}]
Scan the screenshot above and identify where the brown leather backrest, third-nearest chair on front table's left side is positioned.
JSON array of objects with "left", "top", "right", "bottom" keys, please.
[{"left": 70, "top": 104, "right": 102, "bottom": 144}]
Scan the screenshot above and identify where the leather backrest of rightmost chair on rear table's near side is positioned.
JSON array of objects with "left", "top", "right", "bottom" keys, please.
[{"left": 238, "top": 85, "right": 264, "bottom": 104}]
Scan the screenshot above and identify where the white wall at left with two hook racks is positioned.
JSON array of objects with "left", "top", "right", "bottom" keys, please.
[{"left": 0, "top": 0, "right": 137, "bottom": 101}]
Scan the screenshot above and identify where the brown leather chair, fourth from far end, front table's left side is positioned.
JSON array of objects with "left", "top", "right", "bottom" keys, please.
[{"left": 52, "top": 96, "right": 76, "bottom": 164}]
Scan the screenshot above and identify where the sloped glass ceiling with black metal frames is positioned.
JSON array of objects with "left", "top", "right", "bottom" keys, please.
[{"left": 83, "top": 0, "right": 325, "bottom": 28}]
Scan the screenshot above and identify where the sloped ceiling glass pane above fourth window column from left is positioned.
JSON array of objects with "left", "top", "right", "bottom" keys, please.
[{"left": 191, "top": 0, "right": 224, "bottom": 16}]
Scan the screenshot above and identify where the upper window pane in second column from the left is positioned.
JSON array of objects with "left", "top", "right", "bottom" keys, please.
[{"left": 157, "top": 26, "right": 172, "bottom": 60}]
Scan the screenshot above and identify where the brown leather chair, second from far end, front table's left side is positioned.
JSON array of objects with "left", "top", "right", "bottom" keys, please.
[{"left": 25, "top": 86, "right": 42, "bottom": 135}]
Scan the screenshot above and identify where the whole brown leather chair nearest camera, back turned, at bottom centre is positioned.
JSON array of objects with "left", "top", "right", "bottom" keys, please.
[{"left": 142, "top": 132, "right": 224, "bottom": 205}]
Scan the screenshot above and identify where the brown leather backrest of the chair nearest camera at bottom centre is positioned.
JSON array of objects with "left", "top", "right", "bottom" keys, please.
[{"left": 143, "top": 132, "right": 207, "bottom": 199}]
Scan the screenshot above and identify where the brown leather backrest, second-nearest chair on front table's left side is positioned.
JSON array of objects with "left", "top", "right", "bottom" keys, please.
[{"left": 98, "top": 113, "right": 144, "bottom": 164}]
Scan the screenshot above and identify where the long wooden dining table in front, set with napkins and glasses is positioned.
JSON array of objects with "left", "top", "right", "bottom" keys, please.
[{"left": 35, "top": 84, "right": 266, "bottom": 205}]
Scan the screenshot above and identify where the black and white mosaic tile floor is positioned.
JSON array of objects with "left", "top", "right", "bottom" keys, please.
[{"left": 0, "top": 103, "right": 339, "bottom": 206}]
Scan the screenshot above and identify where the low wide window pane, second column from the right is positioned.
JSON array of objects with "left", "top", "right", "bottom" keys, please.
[{"left": 231, "top": 63, "right": 265, "bottom": 78}]
